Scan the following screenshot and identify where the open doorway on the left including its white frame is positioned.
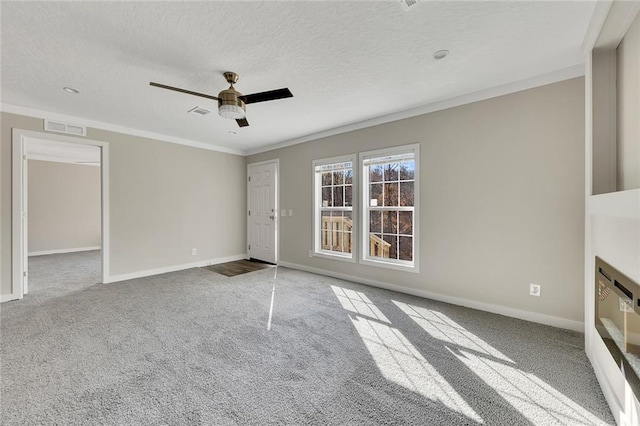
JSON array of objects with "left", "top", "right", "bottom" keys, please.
[{"left": 12, "top": 129, "right": 108, "bottom": 299}]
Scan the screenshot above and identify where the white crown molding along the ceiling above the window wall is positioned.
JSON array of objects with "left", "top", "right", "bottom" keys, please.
[{"left": 247, "top": 63, "right": 585, "bottom": 155}]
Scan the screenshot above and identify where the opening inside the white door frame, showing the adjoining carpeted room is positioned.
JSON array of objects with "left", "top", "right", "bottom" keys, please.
[{"left": 25, "top": 139, "right": 101, "bottom": 294}]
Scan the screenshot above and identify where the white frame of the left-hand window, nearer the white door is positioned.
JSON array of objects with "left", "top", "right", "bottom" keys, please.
[{"left": 311, "top": 154, "right": 359, "bottom": 263}]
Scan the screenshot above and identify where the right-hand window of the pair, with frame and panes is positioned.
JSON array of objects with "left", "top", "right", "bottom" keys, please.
[{"left": 360, "top": 144, "right": 419, "bottom": 272}]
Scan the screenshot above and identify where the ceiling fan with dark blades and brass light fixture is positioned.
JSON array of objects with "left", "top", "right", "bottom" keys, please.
[{"left": 149, "top": 71, "right": 293, "bottom": 127}]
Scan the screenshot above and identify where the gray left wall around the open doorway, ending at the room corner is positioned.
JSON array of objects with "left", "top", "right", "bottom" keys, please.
[{"left": 0, "top": 113, "right": 246, "bottom": 295}]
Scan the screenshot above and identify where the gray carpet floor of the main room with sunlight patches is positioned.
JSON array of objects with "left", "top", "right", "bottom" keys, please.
[{"left": 0, "top": 260, "right": 614, "bottom": 425}]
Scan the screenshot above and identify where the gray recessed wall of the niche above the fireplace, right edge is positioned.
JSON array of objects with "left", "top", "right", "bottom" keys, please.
[{"left": 617, "top": 15, "right": 640, "bottom": 190}]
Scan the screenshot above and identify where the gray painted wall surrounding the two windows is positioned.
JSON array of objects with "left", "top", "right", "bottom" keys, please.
[{"left": 247, "top": 78, "right": 585, "bottom": 321}]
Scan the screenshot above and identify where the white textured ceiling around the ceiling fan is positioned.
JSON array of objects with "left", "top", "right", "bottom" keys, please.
[{"left": 0, "top": 0, "right": 594, "bottom": 152}]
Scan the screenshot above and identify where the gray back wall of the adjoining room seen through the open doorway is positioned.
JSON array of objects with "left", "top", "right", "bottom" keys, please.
[{"left": 27, "top": 160, "right": 101, "bottom": 254}]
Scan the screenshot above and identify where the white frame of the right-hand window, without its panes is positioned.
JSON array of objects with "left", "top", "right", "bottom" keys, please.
[{"left": 358, "top": 143, "right": 420, "bottom": 273}]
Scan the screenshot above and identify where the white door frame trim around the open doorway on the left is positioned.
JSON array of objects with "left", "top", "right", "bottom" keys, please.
[{"left": 10, "top": 129, "right": 110, "bottom": 301}]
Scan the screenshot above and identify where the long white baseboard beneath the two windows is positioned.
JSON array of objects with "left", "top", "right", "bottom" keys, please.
[{"left": 278, "top": 262, "right": 584, "bottom": 333}]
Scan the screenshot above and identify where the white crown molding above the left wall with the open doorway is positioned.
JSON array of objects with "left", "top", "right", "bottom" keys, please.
[{"left": 0, "top": 102, "right": 247, "bottom": 156}]
